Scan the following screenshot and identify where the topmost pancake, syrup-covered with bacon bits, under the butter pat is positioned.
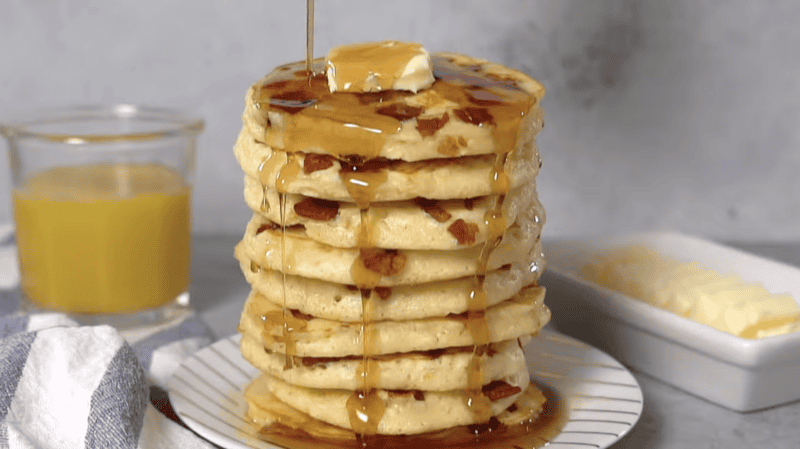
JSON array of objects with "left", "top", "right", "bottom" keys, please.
[{"left": 242, "top": 53, "right": 544, "bottom": 163}]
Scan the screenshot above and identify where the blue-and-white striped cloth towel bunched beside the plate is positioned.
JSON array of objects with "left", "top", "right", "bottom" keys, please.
[{"left": 0, "top": 314, "right": 214, "bottom": 449}]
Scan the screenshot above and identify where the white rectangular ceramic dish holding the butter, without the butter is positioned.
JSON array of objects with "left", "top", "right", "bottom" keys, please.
[{"left": 542, "top": 233, "right": 800, "bottom": 412}]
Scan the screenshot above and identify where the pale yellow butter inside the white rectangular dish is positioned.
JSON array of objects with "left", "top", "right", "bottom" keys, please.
[{"left": 582, "top": 245, "right": 800, "bottom": 338}]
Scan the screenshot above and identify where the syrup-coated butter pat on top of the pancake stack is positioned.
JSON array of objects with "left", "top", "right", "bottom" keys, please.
[{"left": 325, "top": 41, "right": 434, "bottom": 93}]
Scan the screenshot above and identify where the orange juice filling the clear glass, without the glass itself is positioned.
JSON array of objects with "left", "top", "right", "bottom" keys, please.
[{"left": 13, "top": 164, "right": 191, "bottom": 314}]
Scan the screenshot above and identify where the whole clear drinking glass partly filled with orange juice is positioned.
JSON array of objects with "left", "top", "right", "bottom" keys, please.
[{"left": 0, "top": 105, "right": 203, "bottom": 328}]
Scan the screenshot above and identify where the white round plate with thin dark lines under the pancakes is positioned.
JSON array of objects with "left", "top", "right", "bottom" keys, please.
[{"left": 169, "top": 330, "right": 643, "bottom": 449}]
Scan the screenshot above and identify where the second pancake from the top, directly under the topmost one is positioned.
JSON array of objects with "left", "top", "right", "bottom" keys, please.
[{"left": 234, "top": 128, "right": 539, "bottom": 202}]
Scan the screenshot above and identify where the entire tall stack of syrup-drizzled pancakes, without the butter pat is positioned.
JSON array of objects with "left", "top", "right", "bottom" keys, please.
[{"left": 235, "top": 47, "right": 550, "bottom": 438}]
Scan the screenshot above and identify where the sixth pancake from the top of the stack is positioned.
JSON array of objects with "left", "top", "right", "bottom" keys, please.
[{"left": 239, "top": 287, "right": 550, "bottom": 357}]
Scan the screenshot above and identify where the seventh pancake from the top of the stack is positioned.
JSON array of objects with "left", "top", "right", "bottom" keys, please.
[{"left": 241, "top": 334, "right": 528, "bottom": 391}]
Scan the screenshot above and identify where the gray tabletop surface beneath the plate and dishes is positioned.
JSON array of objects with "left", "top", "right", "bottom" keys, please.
[{"left": 191, "top": 235, "right": 800, "bottom": 449}]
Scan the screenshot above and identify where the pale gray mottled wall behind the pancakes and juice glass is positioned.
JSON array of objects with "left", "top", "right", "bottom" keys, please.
[{"left": 0, "top": 0, "right": 800, "bottom": 240}]
